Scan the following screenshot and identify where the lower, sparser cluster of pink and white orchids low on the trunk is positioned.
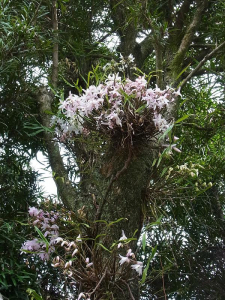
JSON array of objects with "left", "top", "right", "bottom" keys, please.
[{"left": 21, "top": 207, "right": 143, "bottom": 300}]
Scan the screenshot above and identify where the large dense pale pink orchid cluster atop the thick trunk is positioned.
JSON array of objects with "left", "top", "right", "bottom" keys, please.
[{"left": 52, "top": 73, "right": 180, "bottom": 145}]
